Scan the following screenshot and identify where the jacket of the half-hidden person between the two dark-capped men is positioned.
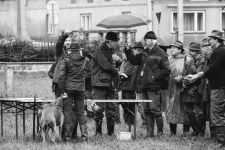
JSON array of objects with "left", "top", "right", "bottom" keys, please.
[{"left": 119, "top": 60, "right": 137, "bottom": 90}]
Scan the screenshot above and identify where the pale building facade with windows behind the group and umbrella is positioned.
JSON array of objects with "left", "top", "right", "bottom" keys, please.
[{"left": 0, "top": 0, "right": 225, "bottom": 45}]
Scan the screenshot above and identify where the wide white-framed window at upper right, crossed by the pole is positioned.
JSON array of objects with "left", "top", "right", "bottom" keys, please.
[{"left": 172, "top": 11, "right": 205, "bottom": 33}]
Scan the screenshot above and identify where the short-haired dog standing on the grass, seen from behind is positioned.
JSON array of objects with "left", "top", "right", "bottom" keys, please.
[{"left": 38, "top": 97, "right": 64, "bottom": 143}]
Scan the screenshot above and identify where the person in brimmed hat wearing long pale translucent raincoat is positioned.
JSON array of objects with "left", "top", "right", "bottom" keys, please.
[{"left": 166, "top": 41, "right": 190, "bottom": 136}]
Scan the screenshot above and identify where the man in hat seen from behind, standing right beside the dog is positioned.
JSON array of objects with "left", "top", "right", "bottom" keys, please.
[{"left": 58, "top": 34, "right": 91, "bottom": 141}]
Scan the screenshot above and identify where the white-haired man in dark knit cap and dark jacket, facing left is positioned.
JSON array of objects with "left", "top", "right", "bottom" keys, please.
[{"left": 125, "top": 31, "right": 170, "bottom": 138}]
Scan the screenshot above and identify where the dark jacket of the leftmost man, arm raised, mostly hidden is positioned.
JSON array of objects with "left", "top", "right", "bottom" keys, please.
[{"left": 52, "top": 35, "right": 68, "bottom": 83}]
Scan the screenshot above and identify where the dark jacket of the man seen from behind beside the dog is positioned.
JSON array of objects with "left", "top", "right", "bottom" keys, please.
[{"left": 58, "top": 51, "right": 86, "bottom": 93}]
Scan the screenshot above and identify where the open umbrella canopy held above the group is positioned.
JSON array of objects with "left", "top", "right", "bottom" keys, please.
[{"left": 97, "top": 15, "right": 151, "bottom": 29}]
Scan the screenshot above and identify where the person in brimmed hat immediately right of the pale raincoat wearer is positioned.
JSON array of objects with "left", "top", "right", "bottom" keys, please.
[{"left": 176, "top": 42, "right": 206, "bottom": 136}]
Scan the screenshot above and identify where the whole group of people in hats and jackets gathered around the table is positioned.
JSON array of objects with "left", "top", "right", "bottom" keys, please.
[{"left": 49, "top": 30, "right": 225, "bottom": 145}]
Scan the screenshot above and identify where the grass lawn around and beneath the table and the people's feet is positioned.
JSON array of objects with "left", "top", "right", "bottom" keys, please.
[{"left": 0, "top": 72, "right": 224, "bottom": 150}]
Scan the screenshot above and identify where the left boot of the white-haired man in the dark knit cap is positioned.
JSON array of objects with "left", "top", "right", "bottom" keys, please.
[{"left": 144, "top": 113, "right": 155, "bottom": 138}]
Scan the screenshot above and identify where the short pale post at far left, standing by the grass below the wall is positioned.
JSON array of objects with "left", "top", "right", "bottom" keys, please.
[{"left": 4, "top": 66, "right": 14, "bottom": 97}]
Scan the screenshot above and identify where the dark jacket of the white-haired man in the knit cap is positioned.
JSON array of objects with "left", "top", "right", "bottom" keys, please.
[{"left": 125, "top": 44, "right": 170, "bottom": 90}]
